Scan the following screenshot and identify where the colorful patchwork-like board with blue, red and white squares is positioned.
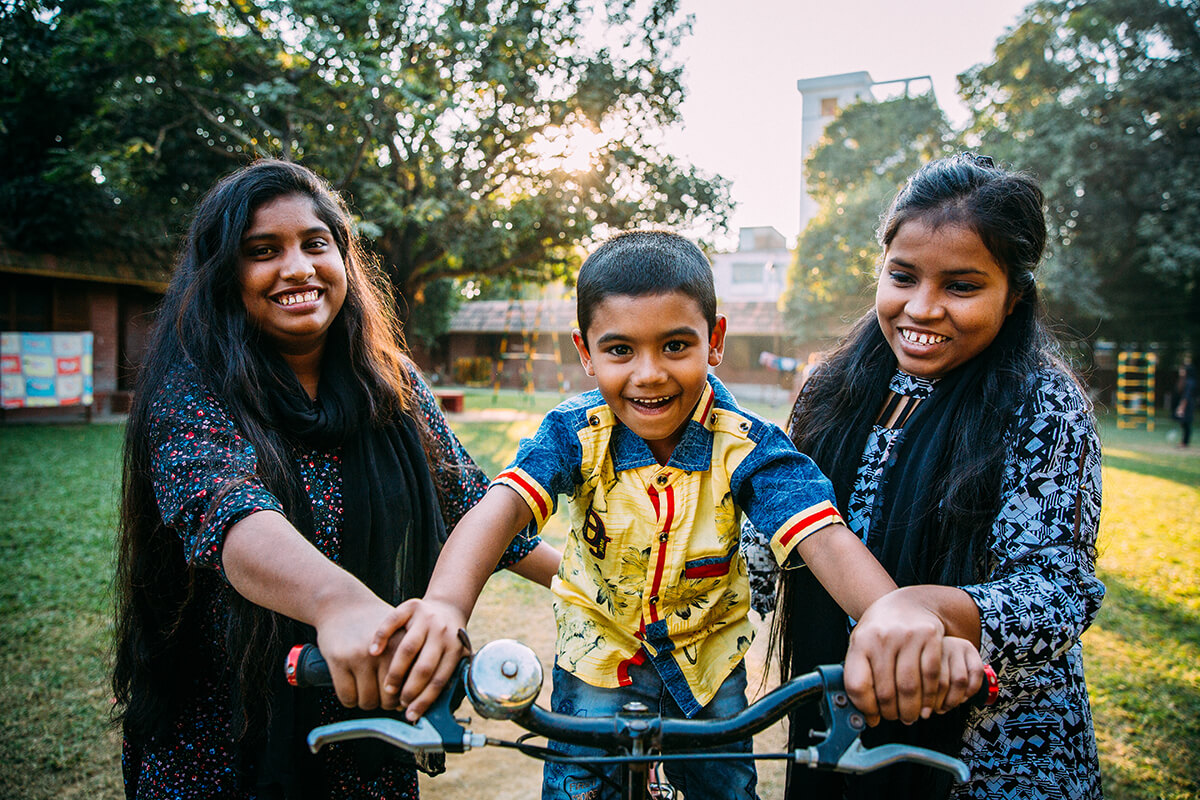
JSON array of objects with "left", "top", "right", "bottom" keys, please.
[{"left": 0, "top": 331, "right": 92, "bottom": 409}]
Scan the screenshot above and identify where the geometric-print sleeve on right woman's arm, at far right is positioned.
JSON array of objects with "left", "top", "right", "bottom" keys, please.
[{"left": 964, "top": 379, "right": 1104, "bottom": 678}]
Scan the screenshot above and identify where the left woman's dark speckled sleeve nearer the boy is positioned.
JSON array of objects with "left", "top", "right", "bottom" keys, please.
[{"left": 410, "top": 372, "right": 541, "bottom": 571}]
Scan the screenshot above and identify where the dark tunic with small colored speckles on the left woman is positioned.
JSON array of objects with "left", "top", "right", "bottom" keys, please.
[{"left": 122, "top": 368, "right": 538, "bottom": 800}]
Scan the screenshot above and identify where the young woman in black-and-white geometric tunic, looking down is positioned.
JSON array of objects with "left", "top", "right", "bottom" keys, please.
[{"left": 748, "top": 154, "right": 1104, "bottom": 800}]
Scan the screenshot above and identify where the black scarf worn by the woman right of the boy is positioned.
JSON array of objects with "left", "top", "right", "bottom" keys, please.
[{"left": 787, "top": 357, "right": 986, "bottom": 800}]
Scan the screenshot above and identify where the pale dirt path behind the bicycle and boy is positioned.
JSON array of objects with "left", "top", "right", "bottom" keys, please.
[{"left": 421, "top": 575, "right": 784, "bottom": 800}]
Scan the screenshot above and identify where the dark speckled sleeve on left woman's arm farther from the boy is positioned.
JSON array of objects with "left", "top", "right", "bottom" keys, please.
[{"left": 149, "top": 373, "right": 283, "bottom": 575}]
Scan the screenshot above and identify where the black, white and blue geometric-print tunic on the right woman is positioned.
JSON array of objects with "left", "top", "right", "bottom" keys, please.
[{"left": 743, "top": 368, "right": 1104, "bottom": 800}]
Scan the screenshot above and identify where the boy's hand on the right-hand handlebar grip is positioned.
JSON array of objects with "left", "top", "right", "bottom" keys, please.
[{"left": 844, "top": 593, "right": 945, "bottom": 726}]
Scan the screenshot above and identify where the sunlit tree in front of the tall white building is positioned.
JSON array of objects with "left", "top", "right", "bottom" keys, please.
[{"left": 782, "top": 94, "right": 955, "bottom": 338}]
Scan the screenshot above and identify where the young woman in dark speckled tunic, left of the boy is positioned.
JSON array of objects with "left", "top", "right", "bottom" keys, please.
[{"left": 113, "top": 161, "right": 558, "bottom": 799}]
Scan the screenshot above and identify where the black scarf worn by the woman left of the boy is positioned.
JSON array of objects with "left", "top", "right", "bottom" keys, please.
[{"left": 244, "top": 350, "right": 446, "bottom": 800}]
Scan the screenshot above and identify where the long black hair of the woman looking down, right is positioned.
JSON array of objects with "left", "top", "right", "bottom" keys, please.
[{"left": 773, "top": 154, "right": 1072, "bottom": 674}]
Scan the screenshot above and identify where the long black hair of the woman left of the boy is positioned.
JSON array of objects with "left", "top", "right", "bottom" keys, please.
[{"left": 113, "top": 160, "right": 430, "bottom": 736}]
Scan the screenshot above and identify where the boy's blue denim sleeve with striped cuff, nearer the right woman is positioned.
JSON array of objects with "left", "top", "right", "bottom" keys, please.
[{"left": 731, "top": 420, "right": 842, "bottom": 569}]
